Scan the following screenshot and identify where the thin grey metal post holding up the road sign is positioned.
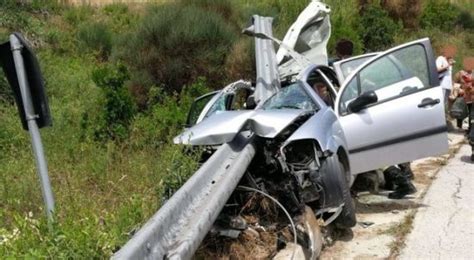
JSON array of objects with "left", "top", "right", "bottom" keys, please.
[{"left": 10, "top": 35, "right": 54, "bottom": 224}]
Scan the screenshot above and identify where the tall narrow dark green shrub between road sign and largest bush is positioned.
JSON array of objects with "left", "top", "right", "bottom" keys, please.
[{"left": 92, "top": 64, "right": 135, "bottom": 140}]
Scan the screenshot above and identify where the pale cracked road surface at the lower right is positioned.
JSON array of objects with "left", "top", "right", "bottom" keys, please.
[{"left": 400, "top": 145, "right": 474, "bottom": 259}]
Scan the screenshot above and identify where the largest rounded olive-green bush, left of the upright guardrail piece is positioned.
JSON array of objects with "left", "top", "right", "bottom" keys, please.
[{"left": 117, "top": 1, "right": 240, "bottom": 97}]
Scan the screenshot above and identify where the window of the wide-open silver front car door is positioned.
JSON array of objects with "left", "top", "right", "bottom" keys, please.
[{"left": 339, "top": 45, "right": 430, "bottom": 113}]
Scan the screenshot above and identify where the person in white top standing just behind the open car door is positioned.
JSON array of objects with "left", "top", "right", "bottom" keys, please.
[{"left": 436, "top": 45, "right": 456, "bottom": 108}]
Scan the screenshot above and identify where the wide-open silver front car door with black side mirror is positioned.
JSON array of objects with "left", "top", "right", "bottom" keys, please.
[{"left": 336, "top": 39, "right": 448, "bottom": 174}]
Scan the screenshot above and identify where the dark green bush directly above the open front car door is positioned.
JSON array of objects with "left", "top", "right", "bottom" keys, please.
[{"left": 360, "top": 4, "right": 401, "bottom": 51}]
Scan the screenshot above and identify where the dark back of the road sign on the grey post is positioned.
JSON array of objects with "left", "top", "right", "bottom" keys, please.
[{"left": 0, "top": 33, "right": 52, "bottom": 130}]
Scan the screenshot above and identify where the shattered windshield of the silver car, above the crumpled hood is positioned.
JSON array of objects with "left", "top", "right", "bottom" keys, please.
[{"left": 262, "top": 82, "right": 318, "bottom": 110}]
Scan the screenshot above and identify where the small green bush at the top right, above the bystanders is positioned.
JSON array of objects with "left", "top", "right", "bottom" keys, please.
[{"left": 420, "top": 0, "right": 458, "bottom": 32}]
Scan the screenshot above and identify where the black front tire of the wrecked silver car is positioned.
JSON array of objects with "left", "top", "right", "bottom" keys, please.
[{"left": 334, "top": 156, "right": 357, "bottom": 229}]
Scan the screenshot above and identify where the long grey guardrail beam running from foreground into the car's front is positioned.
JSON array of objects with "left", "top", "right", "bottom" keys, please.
[{"left": 112, "top": 133, "right": 255, "bottom": 259}]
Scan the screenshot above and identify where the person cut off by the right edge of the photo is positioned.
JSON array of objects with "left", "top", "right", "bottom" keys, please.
[{"left": 459, "top": 57, "right": 474, "bottom": 161}]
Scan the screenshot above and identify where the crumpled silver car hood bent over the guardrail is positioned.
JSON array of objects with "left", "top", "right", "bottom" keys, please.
[{"left": 173, "top": 109, "right": 309, "bottom": 145}]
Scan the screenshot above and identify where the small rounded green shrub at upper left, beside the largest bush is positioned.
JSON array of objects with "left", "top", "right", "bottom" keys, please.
[{"left": 77, "top": 22, "right": 112, "bottom": 60}]
